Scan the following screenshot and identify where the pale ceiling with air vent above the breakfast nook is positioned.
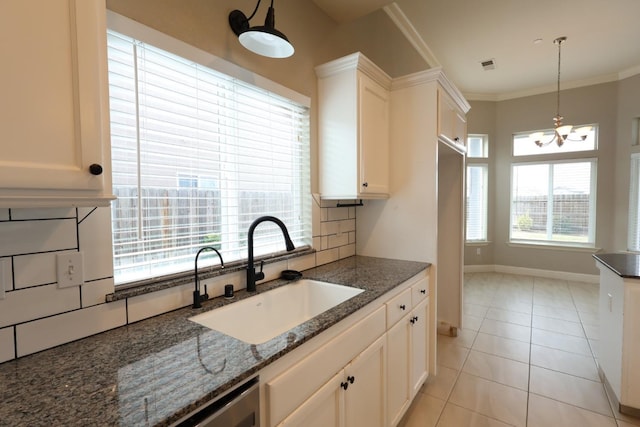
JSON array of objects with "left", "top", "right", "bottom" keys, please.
[{"left": 313, "top": 0, "right": 640, "bottom": 100}]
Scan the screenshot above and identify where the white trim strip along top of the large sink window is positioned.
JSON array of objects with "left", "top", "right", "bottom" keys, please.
[{"left": 107, "top": 10, "right": 311, "bottom": 108}]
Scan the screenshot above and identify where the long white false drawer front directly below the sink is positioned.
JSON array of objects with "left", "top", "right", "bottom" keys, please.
[{"left": 265, "top": 307, "right": 385, "bottom": 426}]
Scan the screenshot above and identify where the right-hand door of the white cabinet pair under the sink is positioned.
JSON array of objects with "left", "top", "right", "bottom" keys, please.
[{"left": 344, "top": 336, "right": 387, "bottom": 427}]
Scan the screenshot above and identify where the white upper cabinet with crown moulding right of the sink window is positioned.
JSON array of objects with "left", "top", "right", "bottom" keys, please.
[{"left": 316, "top": 53, "right": 391, "bottom": 199}]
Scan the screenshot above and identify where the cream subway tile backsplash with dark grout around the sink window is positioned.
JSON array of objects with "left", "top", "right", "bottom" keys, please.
[{"left": 0, "top": 196, "right": 356, "bottom": 363}]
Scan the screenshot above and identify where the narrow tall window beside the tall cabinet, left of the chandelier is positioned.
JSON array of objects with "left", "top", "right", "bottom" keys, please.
[{"left": 465, "top": 135, "right": 489, "bottom": 243}]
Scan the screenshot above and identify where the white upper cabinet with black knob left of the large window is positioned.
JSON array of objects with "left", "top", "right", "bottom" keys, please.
[{"left": 0, "top": 0, "right": 114, "bottom": 208}]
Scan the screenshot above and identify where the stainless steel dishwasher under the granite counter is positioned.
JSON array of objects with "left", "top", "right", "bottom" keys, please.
[{"left": 174, "top": 377, "right": 260, "bottom": 427}]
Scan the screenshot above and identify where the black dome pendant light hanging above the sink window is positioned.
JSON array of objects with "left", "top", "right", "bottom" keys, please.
[{"left": 229, "top": 0, "right": 295, "bottom": 58}]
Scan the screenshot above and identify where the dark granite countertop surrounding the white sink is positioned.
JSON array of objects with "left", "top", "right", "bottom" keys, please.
[{"left": 0, "top": 256, "right": 429, "bottom": 426}]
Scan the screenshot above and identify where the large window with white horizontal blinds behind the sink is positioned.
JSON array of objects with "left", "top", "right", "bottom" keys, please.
[{"left": 108, "top": 30, "right": 311, "bottom": 285}]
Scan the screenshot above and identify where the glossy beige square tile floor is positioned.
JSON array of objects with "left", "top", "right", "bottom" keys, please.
[{"left": 400, "top": 273, "right": 640, "bottom": 427}]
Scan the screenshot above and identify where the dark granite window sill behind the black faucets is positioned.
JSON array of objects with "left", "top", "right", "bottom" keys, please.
[{"left": 105, "top": 246, "right": 316, "bottom": 302}]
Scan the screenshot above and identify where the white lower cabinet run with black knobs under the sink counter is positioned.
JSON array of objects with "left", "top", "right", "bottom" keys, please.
[{"left": 260, "top": 273, "right": 429, "bottom": 427}]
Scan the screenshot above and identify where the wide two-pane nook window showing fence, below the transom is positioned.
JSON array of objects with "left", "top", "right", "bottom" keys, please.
[{"left": 509, "top": 159, "right": 597, "bottom": 247}]
